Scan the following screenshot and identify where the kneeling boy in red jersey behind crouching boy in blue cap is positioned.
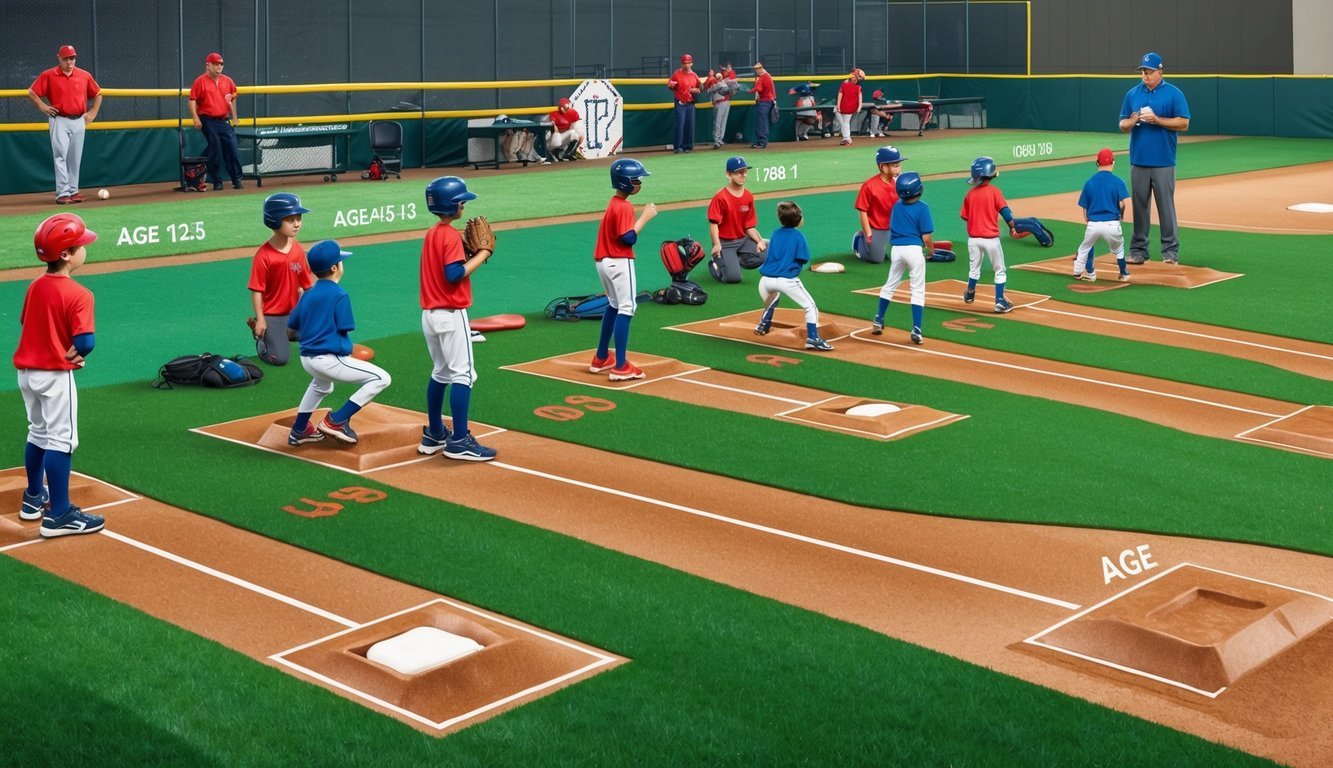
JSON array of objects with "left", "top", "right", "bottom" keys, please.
[{"left": 245, "top": 192, "right": 315, "bottom": 365}]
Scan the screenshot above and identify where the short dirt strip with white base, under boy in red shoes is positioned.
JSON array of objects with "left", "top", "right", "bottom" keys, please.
[{"left": 504, "top": 349, "right": 966, "bottom": 440}]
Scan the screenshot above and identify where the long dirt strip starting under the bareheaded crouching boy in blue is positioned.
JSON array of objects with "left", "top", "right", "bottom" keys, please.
[{"left": 673, "top": 305, "right": 1333, "bottom": 459}]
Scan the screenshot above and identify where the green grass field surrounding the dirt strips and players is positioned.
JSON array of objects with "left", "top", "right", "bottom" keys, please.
[{"left": 0, "top": 132, "right": 1333, "bottom": 767}]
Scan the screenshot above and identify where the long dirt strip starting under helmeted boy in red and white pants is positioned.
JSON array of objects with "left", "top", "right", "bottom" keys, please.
[{"left": 857, "top": 280, "right": 1333, "bottom": 380}]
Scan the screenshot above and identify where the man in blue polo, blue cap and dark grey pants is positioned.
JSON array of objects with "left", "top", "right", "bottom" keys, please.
[{"left": 1120, "top": 53, "right": 1189, "bottom": 264}]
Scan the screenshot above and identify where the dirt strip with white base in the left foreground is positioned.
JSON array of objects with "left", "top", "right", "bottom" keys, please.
[{"left": 0, "top": 467, "right": 625, "bottom": 736}]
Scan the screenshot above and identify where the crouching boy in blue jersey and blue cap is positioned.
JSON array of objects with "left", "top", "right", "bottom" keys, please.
[{"left": 287, "top": 240, "right": 391, "bottom": 445}]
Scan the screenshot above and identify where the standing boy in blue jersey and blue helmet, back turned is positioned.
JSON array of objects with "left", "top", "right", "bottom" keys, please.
[{"left": 870, "top": 172, "right": 934, "bottom": 344}]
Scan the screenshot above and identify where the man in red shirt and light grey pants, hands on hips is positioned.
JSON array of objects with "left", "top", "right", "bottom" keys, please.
[{"left": 28, "top": 45, "right": 101, "bottom": 205}]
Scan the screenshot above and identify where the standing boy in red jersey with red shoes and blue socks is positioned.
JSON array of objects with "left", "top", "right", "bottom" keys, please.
[{"left": 588, "top": 157, "right": 657, "bottom": 381}]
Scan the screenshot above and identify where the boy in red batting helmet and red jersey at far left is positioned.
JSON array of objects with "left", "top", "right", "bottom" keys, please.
[{"left": 13, "top": 213, "right": 105, "bottom": 539}]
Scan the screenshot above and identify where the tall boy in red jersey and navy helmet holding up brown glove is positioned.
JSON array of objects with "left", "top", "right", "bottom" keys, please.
[{"left": 417, "top": 176, "right": 496, "bottom": 461}]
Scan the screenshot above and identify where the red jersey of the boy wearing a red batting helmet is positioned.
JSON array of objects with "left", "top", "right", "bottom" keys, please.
[{"left": 13, "top": 275, "right": 93, "bottom": 371}]
